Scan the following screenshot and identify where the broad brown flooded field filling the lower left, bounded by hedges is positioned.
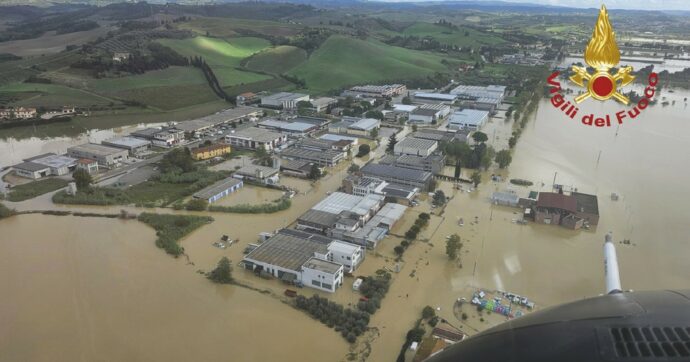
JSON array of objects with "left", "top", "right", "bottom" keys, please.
[{"left": 0, "top": 216, "right": 347, "bottom": 361}]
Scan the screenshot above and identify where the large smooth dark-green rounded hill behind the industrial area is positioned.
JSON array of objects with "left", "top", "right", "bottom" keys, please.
[{"left": 289, "top": 35, "right": 447, "bottom": 93}]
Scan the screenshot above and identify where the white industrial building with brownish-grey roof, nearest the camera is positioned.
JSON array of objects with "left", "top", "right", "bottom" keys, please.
[{"left": 242, "top": 229, "right": 352, "bottom": 293}]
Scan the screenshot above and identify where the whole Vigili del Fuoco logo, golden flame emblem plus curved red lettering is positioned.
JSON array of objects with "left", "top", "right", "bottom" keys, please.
[{"left": 547, "top": 5, "right": 659, "bottom": 127}]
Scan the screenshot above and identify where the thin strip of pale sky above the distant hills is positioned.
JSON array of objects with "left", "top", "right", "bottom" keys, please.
[{"left": 372, "top": 0, "right": 690, "bottom": 11}]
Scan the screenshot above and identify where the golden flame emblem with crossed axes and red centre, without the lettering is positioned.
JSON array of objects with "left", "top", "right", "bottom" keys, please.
[{"left": 570, "top": 5, "right": 635, "bottom": 105}]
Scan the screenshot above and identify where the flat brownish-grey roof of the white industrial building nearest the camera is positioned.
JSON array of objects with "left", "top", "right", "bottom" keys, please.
[{"left": 244, "top": 230, "right": 328, "bottom": 271}]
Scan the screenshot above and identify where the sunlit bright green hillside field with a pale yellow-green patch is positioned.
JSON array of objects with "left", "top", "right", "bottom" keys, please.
[{"left": 159, "top": 36, "right": 271, "bottom": 87}]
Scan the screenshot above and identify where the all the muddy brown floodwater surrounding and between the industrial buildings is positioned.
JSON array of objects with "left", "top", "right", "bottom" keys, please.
[{"left": 0, "top": 86, "right": 690, "bottom": 361}]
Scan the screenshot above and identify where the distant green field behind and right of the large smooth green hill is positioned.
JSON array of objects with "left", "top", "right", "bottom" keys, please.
[{"left": 402, "top": 23, "right": 505, "bottom": 47}]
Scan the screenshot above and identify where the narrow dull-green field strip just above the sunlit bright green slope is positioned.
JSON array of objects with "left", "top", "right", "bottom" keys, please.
[{"left": 178, "top": 18, "right": 303, "bottom": 38}]
